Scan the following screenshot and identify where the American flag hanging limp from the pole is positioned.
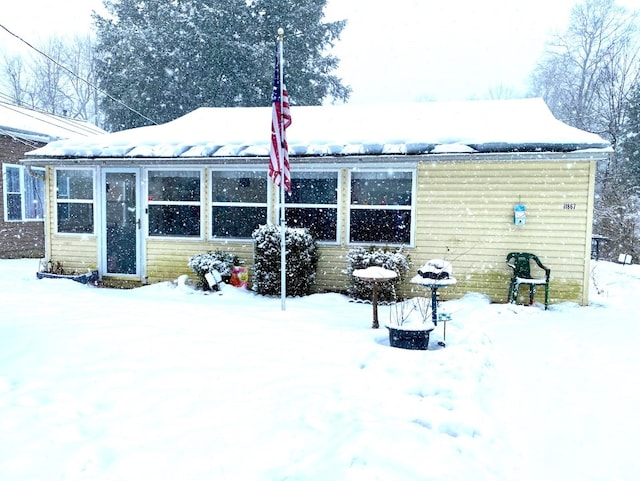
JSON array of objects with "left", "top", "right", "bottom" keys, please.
[{"left": 269, "top": 48, "right": 291, "bottom": 192}]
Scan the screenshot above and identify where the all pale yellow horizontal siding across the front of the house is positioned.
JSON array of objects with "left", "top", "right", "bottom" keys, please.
[{"left": 46, "top": 159, "right": 596, "bottom": 304}]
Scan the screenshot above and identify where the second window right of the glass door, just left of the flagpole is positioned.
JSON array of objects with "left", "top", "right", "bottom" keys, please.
[{"left": 211, "top": 170, "right": 267, "bottom": 239}]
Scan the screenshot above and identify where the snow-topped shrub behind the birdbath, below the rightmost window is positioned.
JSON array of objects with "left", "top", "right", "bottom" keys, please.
[{"left": 343, "top": 246, "right": 409, "bottom": 302}]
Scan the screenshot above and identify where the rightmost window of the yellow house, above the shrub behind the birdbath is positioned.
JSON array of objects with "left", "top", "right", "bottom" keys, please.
[{"left": 349, "top": 170, "right": 413, "bottom": 244}]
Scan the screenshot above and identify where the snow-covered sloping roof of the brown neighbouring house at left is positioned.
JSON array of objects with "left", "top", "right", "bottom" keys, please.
[{"left": 0, "top": 102, "right": 105, "bottom": 143}]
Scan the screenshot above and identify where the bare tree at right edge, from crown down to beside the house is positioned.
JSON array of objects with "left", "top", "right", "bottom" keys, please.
[{"left": 532, "top": 0, "right": 640, "bottom": 259}]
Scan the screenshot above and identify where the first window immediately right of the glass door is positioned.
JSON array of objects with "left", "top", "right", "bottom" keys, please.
[{"left": 148, "top": 170, "right": 202, "bottom": 237}]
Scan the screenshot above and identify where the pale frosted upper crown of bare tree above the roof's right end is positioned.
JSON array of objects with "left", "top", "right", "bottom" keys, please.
[{"left": 532, "top": 0, "right": 638, "bottom": 145}]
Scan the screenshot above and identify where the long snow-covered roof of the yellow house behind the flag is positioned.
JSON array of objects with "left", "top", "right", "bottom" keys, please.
[{"left": 27, "top": 99, "right": 610, "bottom": 160}]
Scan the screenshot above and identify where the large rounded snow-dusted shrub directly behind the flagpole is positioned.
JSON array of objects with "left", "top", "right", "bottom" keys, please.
[{"left": 252, "top": 225, "right": 319, "bottom": 296}]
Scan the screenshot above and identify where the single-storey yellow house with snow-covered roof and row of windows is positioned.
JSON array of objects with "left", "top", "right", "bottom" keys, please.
[{"left": 23, "top": 99, "right": 610, "bottom": 304}]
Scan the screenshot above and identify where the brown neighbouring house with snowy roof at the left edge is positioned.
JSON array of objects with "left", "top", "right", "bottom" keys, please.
[{"left": 0, "top": 102, "right": 104, "bottom": 258}]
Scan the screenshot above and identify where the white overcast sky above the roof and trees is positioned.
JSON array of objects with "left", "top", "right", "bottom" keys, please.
[{"left": 0, "top": 0, "right": 640, "bottom": 103}]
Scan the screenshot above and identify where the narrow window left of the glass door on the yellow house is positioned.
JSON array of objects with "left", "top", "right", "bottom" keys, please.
[{"left": 56, "top": 169, "right": 94, "bottom": 234}]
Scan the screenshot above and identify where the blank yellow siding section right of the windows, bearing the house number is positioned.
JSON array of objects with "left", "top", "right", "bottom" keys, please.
[{"left": 412, "top": 161, "right": 595, "bottom": 304}]
